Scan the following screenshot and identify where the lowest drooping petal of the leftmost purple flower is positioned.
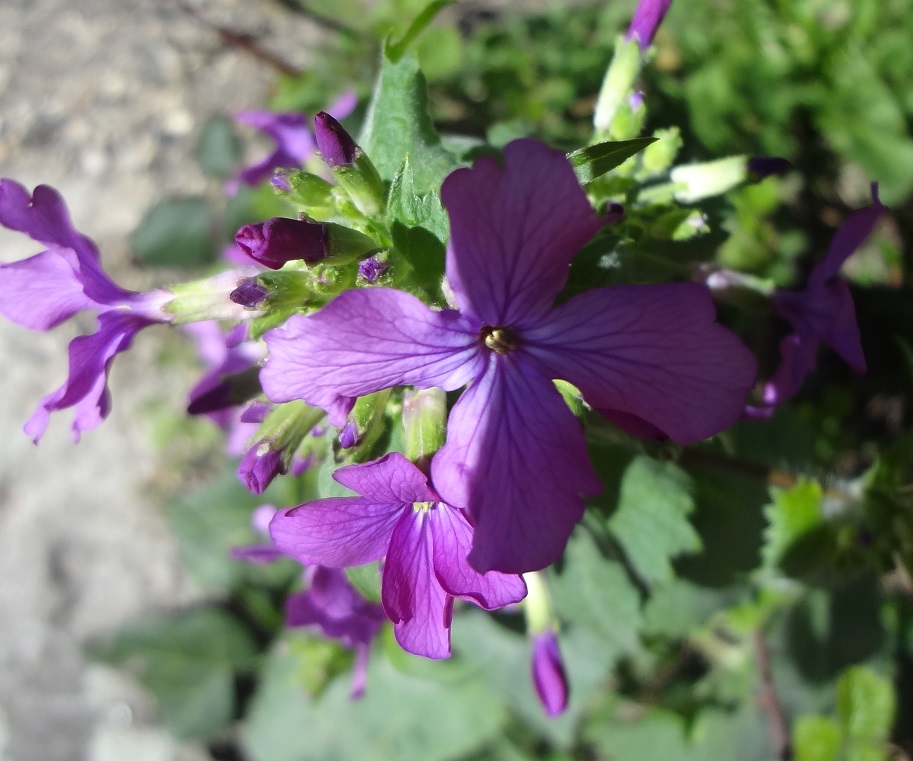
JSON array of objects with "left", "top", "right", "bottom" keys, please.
[{"left": 23, "top": 310, "right": 152, "bottom": 443}]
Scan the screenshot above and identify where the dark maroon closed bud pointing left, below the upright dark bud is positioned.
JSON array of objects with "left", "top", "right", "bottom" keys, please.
[{"left": 235, "top": 217, "right": 330, "bottom": 270}]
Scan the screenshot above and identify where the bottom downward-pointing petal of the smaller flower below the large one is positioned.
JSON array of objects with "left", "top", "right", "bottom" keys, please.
[{"left": 381, "top": 510, "right": 453, "bottom": 658}]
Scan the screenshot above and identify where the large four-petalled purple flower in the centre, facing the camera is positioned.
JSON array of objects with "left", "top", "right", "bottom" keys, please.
[{"left": 260, "top": 140, "right": 755, "bottom": 573}]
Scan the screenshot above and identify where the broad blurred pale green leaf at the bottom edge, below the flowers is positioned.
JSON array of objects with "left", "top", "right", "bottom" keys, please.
[{"left": 242, "top": 647, "right": 510, "bottom": 761}]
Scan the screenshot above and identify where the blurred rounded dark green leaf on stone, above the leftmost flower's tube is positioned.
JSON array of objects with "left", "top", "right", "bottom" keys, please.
[{"left": 130, "top": 196, "right": 216, "bottom": 268}]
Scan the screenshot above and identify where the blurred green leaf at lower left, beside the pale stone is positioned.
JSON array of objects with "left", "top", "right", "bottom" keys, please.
[{"left": 93, "top": 608, "right": 257, "bottom": 738}]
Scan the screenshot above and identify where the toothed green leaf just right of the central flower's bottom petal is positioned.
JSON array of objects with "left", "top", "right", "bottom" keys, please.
[{"left": 608, "top": 456, "right": 701, "bottom": 584}]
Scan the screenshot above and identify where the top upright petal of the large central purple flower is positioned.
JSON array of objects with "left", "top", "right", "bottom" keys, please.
[{"left": 441, "top": 140, "right": 604, "bottom": 327}]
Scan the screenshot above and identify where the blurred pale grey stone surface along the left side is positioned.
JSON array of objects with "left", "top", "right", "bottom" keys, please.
[{"left": 0, "top": 0, "right": 324, "bottom": 761}]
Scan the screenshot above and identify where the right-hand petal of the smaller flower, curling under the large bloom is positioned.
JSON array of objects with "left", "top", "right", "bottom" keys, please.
[{"left": 427, "top": 502, "right": 526, "bottom": 610}]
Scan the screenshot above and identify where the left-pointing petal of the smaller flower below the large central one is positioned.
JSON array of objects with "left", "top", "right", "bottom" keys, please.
[{"left": 269, "top": 497, "right": 403, "bottom": 568}]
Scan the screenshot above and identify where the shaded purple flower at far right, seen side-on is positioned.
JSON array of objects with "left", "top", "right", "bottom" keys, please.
[{"left": 747, "top": 185, "right": 885, "bottom": 417}]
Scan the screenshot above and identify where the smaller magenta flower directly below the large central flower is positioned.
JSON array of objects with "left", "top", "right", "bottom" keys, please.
[{"left": 270, "top": 452, "right": 526, "bottom": 658}]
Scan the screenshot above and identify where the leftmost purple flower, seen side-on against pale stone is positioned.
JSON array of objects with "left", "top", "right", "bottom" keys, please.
[{"left": 0, "top": 180, "right": 173, "bottom": 442}]
